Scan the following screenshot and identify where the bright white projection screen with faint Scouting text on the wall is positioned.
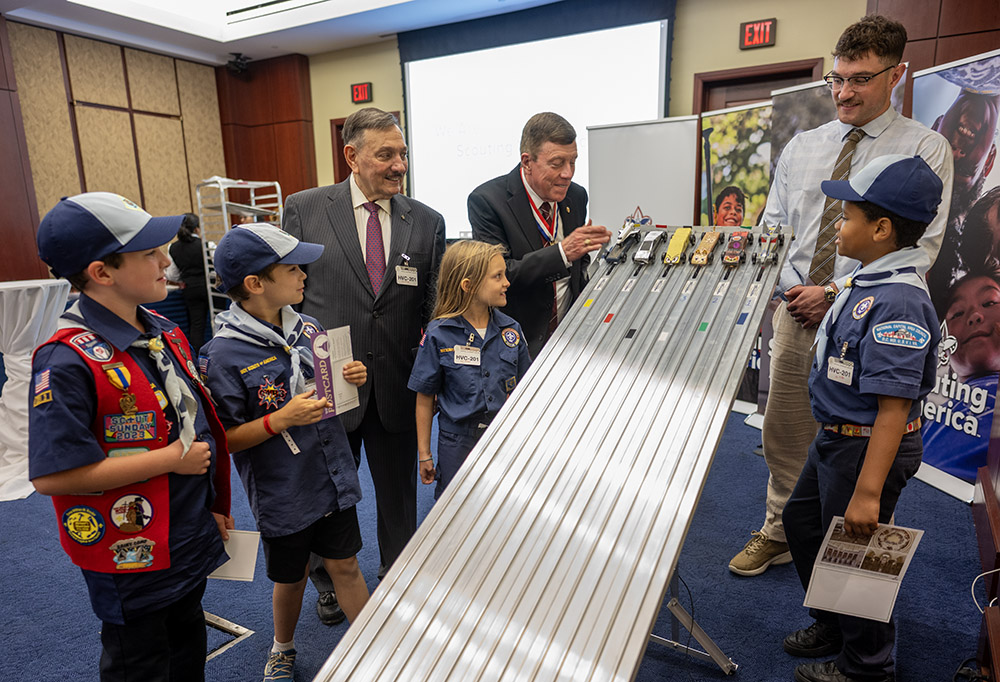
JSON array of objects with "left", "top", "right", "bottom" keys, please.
[{"left": 405, "top": 21, "right": 667, "bottom": 239}]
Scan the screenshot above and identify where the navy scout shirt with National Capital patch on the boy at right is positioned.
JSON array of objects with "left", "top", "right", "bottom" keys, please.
[{"left": 809, "top": 283, "right": 941, "bottom": 426}]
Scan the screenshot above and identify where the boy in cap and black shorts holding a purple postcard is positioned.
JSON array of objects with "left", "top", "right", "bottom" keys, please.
[{"left": 201, "top": 224, "right": 368, "bottom": 680}]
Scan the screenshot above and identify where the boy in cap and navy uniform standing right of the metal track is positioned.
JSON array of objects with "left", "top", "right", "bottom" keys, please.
[{"left": 782, "top": 155, "right": 942, "bottom": 682}]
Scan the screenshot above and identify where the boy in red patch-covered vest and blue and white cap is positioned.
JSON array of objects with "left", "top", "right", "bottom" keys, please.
[{"left": 28, "top": 192, "right": 233, "bottom": 681}]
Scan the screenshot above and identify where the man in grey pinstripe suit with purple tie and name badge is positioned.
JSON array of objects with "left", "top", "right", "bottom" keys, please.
[{"left": 283, "top": 107, "right": 445, "bottom": 624}]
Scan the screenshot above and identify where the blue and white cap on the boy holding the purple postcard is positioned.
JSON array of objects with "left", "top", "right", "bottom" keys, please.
[{"left": 215, "top": 223, "right": 323, "bottom": 291}]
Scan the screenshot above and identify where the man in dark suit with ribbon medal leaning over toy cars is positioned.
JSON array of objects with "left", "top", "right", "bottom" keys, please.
[{"left": 469, "top": 112, "right": 611, "bottom": 357}]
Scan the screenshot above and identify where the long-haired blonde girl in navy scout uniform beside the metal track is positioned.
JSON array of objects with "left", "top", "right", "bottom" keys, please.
[{"left": 407, "top": 241, "right": 531, "bottom": 499}]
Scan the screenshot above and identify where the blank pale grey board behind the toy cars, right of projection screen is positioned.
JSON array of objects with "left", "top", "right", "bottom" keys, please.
[{"left": 587, "top": 116, "right": 698, "bottom": 232}]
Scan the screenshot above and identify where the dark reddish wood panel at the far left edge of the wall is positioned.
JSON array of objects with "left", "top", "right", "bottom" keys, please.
[{"left": 0, "top": 17, "right": 49, "bottom": 281}]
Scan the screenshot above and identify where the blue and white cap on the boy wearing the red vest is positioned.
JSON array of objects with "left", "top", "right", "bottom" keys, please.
[{"left": 38, "top": 192, "right": 184, "bottom": 277}]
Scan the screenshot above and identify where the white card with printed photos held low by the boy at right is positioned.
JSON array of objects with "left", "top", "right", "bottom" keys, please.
[{"left": 803, "top": 516, "right": 924, "bottom": 623}]
